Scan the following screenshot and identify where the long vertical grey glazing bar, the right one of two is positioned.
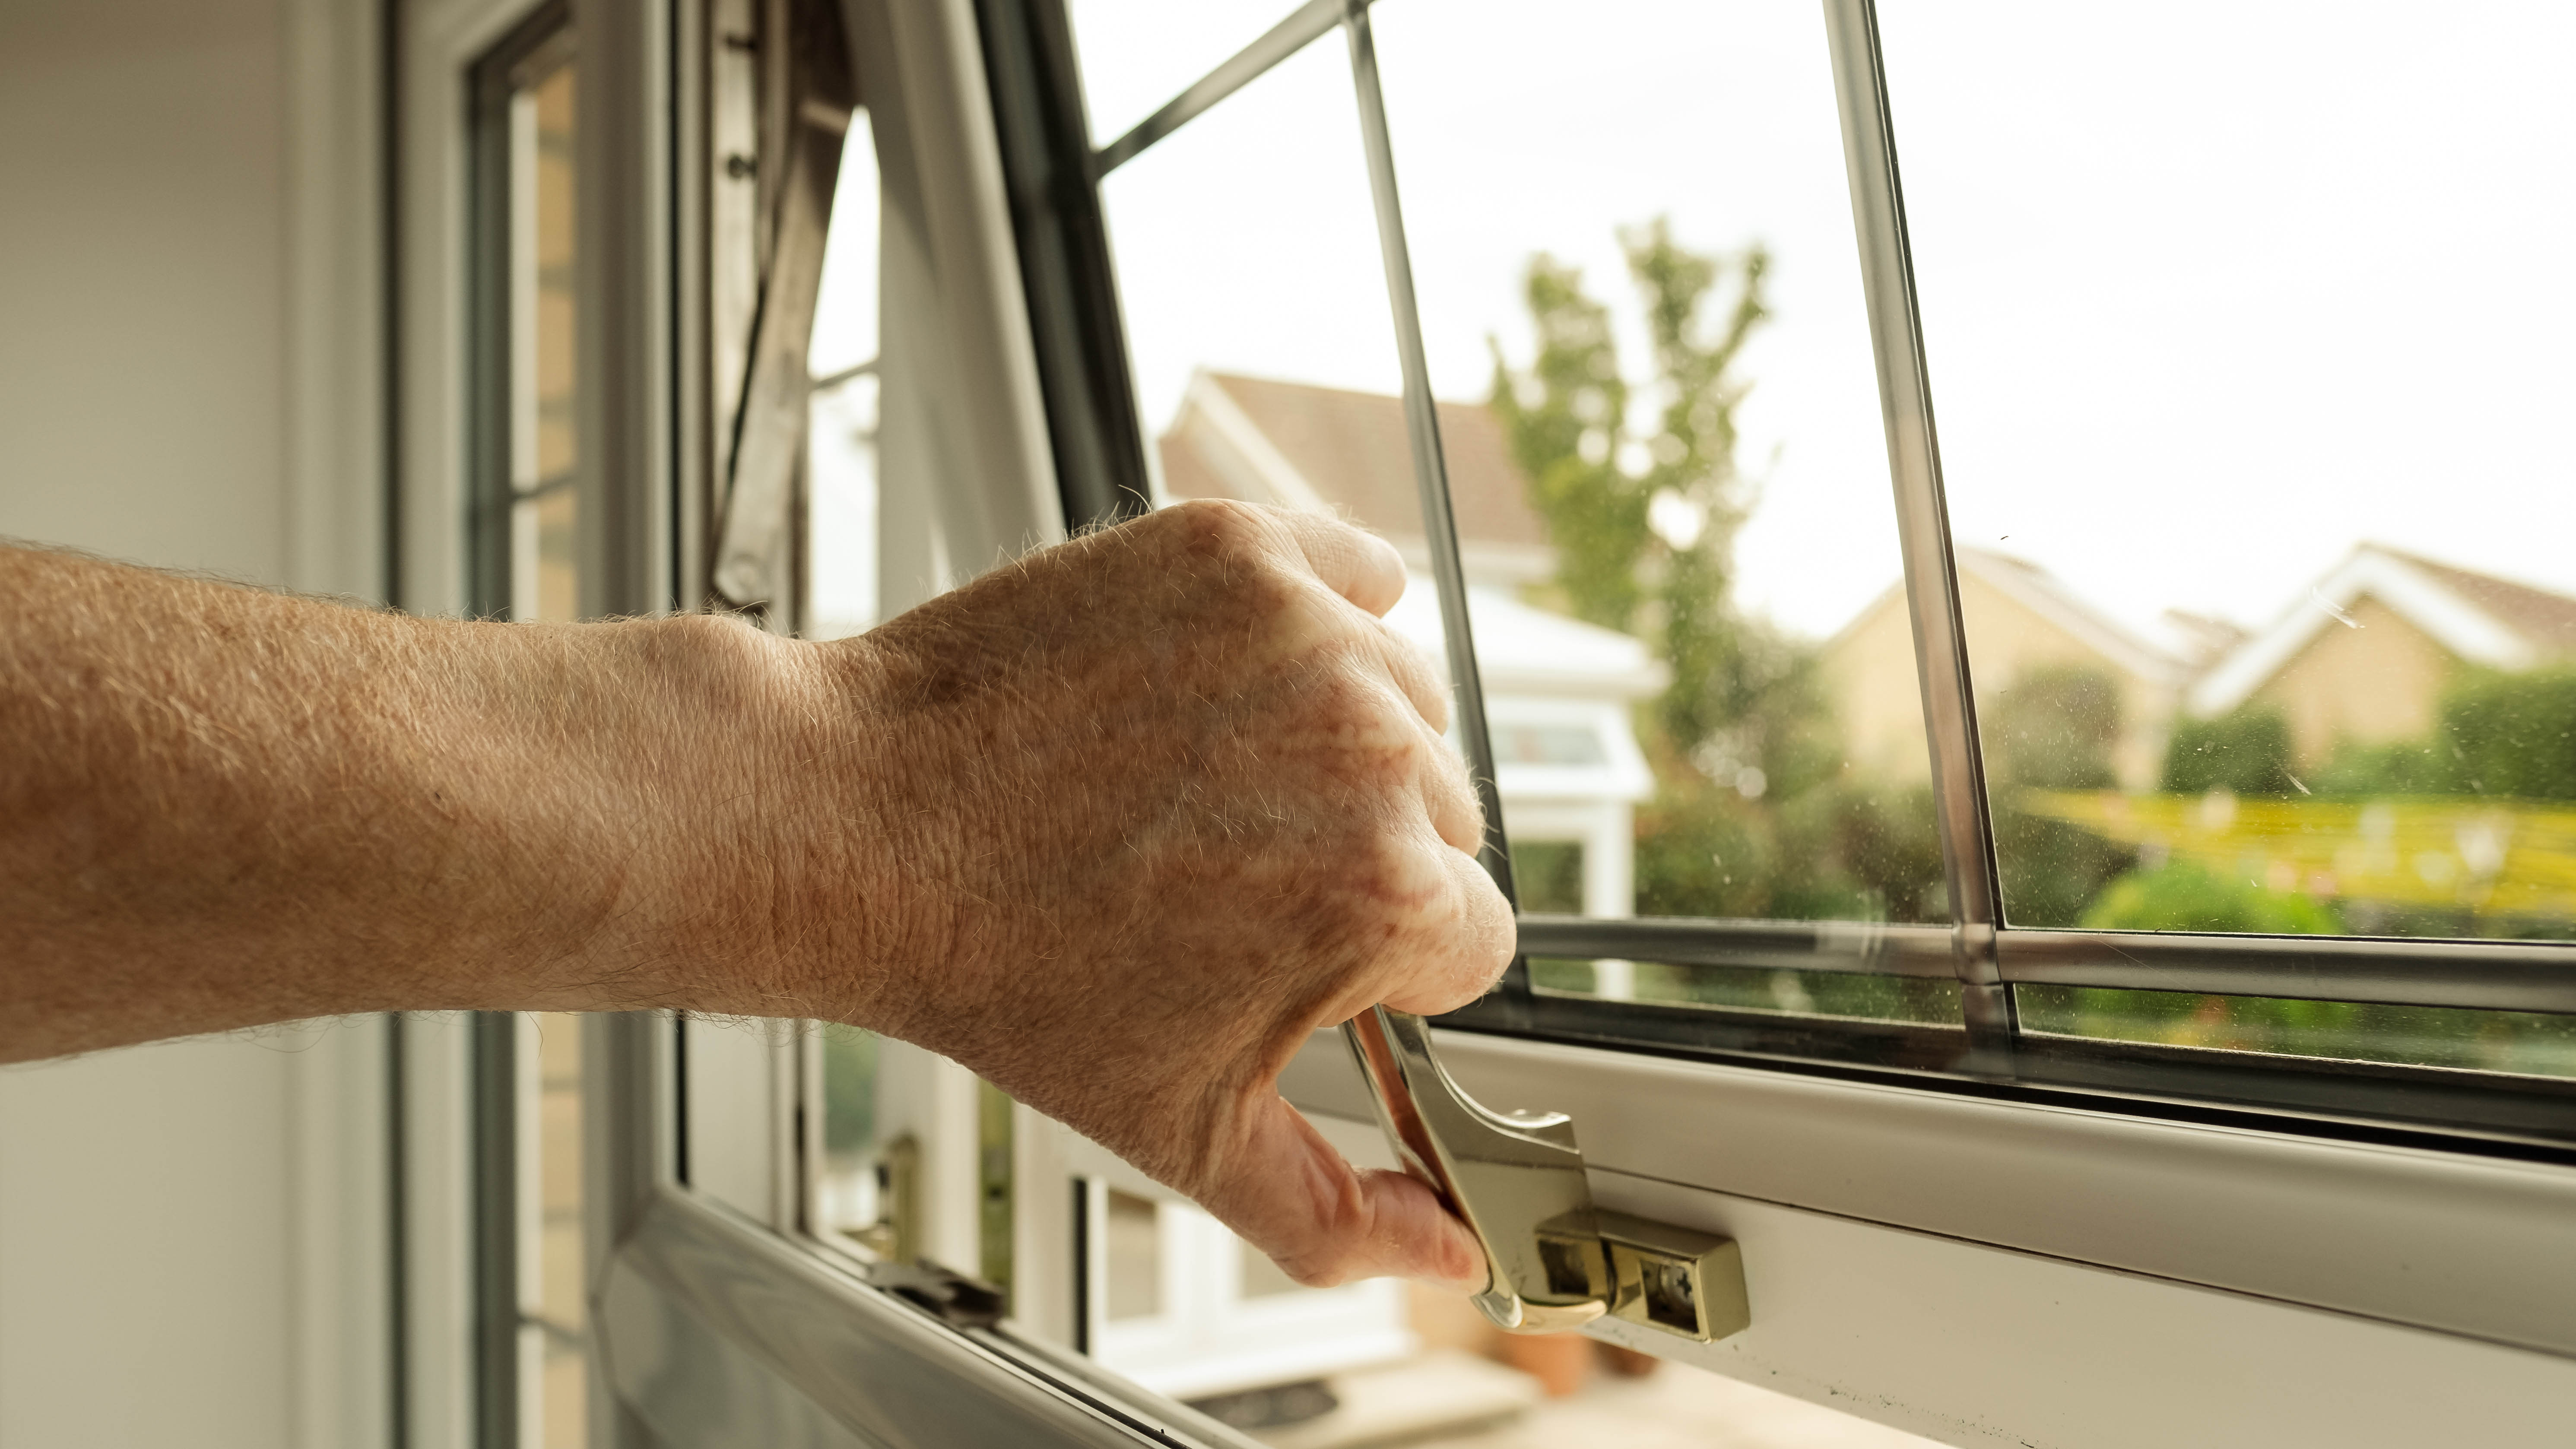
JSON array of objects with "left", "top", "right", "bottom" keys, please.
[{"left": 1824, "top": 0, "right": 2014, "bottom": 1073}]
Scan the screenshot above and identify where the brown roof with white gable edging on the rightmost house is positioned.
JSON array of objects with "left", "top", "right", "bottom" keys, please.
[{"left": 2189, "top": 543, "right": 2576, "bottom": 716}]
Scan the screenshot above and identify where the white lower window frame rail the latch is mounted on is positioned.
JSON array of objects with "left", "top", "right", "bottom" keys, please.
[{"left": 1283, "top": 1032, "right": 2576, "bottom": 1446}]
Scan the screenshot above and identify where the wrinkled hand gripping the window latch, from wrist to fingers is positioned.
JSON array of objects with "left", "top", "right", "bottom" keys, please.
[{"left": 765, "top": 502, "right": 1512, "bottom": 1284}]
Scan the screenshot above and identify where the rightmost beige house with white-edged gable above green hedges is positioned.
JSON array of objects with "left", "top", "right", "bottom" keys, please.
[{"left": 2189, "top": 543, "right": 2576, "bottom": 767}]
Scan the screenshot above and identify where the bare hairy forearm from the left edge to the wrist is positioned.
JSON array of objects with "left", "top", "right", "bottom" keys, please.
[{"left": 0, "top": 548, "right": 840, "bottom": 1060}]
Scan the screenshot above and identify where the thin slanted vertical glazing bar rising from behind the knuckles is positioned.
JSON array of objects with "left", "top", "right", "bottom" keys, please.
[{"left": 1350, "top": 0, "right": 1528, "bottom": 916}]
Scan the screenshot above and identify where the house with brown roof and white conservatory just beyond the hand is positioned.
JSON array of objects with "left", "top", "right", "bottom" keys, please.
[{"left": 1157, "top": 371, "right": 1669, "bottom": 916}]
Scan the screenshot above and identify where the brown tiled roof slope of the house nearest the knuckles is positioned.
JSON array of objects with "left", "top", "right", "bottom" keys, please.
[{"left": 1157, "top": 373, "right": 1548, "bottom": 545}]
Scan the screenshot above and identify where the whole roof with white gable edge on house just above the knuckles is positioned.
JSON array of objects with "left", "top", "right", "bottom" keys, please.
[{"left": 1157, "top": 371, "right": 1548, "bottom": 548}]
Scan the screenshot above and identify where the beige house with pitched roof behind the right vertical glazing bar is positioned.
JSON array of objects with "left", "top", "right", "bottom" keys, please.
[{"left": 1821, "top": 548, "right": 2223, "bottom": 790}]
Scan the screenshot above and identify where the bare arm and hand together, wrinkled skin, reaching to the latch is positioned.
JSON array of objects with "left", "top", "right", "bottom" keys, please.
[{"left": 0, "top": 504, "right": 1512, "bottom": 1284}]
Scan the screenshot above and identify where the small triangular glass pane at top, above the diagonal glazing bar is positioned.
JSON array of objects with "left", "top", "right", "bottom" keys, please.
[{"left": 1066, "top": 0, "right": 1342, "bottom": 147}]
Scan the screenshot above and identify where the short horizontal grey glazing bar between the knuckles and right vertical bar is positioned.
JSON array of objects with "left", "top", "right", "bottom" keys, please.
[{"left": 1520, "top": 916, "right": 1955, "bottom": 978}]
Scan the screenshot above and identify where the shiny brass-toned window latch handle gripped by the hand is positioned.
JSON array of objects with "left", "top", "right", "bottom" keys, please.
[{"left": 1342, "top": 1006, "right": 1752, "bottom": 1344}]
